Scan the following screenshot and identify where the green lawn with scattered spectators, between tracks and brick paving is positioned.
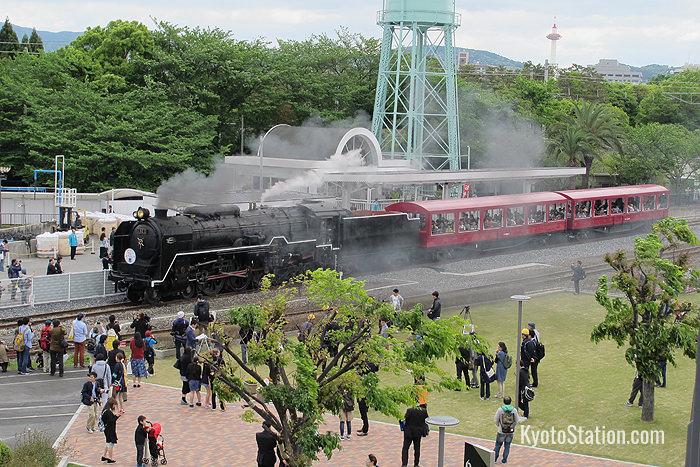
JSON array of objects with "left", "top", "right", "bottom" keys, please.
[{"left": 148, "top": 293, "right": 695, "bottom": 466}]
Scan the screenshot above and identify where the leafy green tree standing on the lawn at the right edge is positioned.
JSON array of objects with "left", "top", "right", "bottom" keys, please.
[{"left": 591, "top": 218, "right": 700, "bottom": 421}]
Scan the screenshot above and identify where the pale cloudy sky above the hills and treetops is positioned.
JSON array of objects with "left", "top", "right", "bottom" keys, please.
[{"left": 5, "top": 0, "right": 700, "bottom": 66}]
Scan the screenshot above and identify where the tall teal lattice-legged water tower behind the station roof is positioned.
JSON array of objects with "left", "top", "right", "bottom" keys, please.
[{"left": 372, "top": 0, "right": 460, "bottom": 170}]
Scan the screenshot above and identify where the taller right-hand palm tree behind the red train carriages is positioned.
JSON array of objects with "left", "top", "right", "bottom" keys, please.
[{"left": 572, "top": 101, "right": 624, "bottom": 188}]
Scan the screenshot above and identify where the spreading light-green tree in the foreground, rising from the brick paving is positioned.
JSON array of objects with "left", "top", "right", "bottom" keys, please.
[{"left": 216, "top": 269, "right": 487, "bottom": 467}]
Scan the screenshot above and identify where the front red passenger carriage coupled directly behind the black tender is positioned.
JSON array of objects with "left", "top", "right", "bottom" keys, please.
[{"left": 386, "top": 192, "right": 568, "bottom": 248}]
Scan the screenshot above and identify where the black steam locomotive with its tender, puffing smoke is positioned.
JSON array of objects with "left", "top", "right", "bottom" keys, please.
[{"left": 110, "top": 202, "right": 419, "bottom": 303}]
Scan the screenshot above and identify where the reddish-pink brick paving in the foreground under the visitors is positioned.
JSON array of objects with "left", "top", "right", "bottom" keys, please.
[{"left": 65, "top": 384, "right": 644, "bottom": 467}]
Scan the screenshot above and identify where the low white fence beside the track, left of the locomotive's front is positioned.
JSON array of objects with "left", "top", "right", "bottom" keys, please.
[{"left": 0, "top": 269, "right": 123, "bottom": 309}]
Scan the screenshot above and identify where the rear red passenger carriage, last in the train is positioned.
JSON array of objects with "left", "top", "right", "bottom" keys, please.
[{"left": 557, "top": 185, "right": 669, "bottom": 232}]
